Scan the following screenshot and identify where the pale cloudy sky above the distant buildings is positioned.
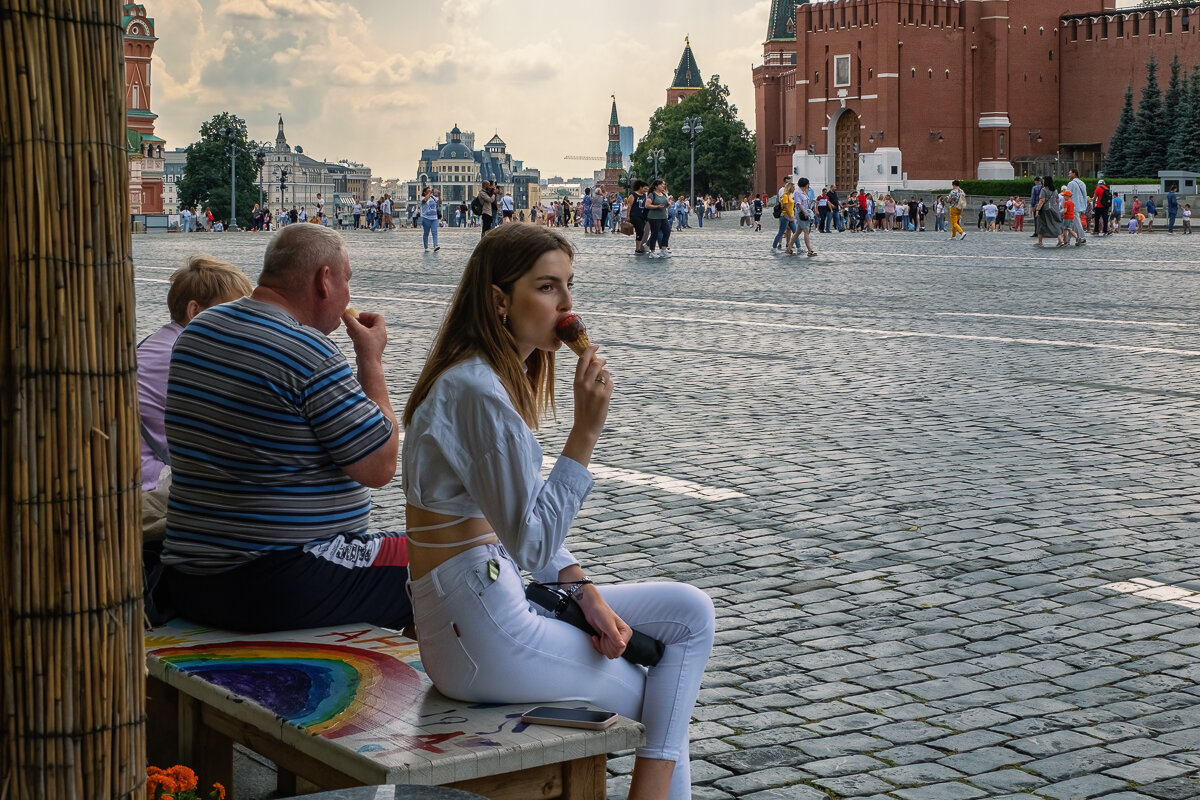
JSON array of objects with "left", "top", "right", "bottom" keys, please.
[{"left": 150, "top": 0, "right": 770, "bottom": 179}]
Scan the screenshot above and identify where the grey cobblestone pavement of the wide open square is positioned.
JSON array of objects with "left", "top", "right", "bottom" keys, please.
[{"left": 134, "top": 218, "right": 1200, "bottom": 800}]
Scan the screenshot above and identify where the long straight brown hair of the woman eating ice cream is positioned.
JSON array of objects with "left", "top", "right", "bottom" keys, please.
[{"left": 403, "top": 224, "right": 575, "bottom": 429}]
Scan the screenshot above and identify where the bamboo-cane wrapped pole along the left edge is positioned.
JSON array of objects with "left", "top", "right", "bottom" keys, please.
[{"left": 0, "top": 0, "right": 145, "bottom": 800}]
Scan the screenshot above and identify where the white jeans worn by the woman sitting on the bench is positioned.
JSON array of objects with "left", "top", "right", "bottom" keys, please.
[{"left": 409, "top": 545, "right": 714, "bottom": 800}]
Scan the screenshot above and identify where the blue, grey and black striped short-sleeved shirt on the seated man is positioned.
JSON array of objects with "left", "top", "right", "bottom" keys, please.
[{"left": 162, "top": 297, "right": 392, "bottom": 573}]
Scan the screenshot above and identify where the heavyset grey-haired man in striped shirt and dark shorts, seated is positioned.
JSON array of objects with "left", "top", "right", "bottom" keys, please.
[{"left": 162, "top": 225, "right": 412, "bottom": 631}]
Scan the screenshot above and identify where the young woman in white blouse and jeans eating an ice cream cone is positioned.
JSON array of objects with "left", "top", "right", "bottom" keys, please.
[{"left": 402, "top": 224, "right": 714, "bottom": 800}]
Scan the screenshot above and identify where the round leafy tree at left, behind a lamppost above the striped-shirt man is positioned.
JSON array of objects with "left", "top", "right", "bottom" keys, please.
[{"left": 176, "top": 112, "right": 262, "bottom": 228}]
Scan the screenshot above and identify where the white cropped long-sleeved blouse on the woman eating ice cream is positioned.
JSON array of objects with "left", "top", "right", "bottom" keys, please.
[{"left": 402, "top": 357, "right": 593, "bottom": 582}]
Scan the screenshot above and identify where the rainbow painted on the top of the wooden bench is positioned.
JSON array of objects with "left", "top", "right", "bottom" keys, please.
[{"left": 152, "top": 642, "right": 422, "bottom": 739}]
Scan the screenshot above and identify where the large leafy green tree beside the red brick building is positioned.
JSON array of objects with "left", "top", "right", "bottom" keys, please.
[{"left": 632, "top": 74, "right": 755, "bottom": 200}]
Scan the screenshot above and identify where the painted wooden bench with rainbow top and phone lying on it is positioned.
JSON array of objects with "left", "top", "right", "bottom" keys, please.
[{"left": 146, "top": 620, "right": 644, "bottom": 800}]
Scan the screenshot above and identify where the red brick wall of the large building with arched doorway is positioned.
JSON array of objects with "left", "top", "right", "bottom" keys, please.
[{"left": 755, "top": 0, "right": 1200, "bottom": 181}]
